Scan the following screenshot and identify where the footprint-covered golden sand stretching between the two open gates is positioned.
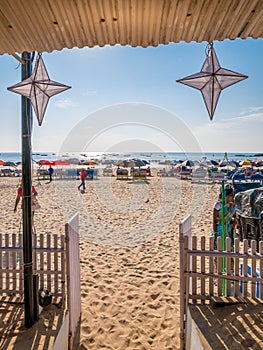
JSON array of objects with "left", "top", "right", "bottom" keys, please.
[{"left": 0, "top": 176, "right": 222, "bottom": 350}]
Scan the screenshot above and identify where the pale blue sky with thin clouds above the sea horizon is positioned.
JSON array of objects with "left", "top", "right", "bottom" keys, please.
[{"left": 0, "top": 39, "right": 263, "bottom": 152}]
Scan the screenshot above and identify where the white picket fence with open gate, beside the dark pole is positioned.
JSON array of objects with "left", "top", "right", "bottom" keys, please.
[{"left": 0, "top": 214, "right": 81, "bottom": 349}]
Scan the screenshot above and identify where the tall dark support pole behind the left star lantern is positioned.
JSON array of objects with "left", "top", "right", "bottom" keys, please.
[{"left": 21, "top": 52, "right": 35, "bottom": 328}]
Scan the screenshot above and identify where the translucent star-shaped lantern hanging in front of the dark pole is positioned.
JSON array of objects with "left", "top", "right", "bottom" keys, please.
[{"left": 7, "top": 54, "right": 71, "bottom": 125}]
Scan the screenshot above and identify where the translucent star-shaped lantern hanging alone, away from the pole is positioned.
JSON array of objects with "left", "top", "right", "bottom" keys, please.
[{"left": 176, "top": 43, "right": 248, "bottom": 120}]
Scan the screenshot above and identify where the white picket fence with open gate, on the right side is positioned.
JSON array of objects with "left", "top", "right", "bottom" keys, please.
[{"left": 179, "top": 215, "right": 263, "bottom": 349}]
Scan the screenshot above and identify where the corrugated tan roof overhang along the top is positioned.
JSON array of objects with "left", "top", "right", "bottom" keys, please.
[{"left": 0, "top": 0, "right": 263, "bottom": 54}]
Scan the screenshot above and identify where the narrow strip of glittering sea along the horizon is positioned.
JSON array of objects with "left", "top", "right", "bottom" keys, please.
[{"left": 0, "top": 152, "right": 263, "bottom": 163}]
